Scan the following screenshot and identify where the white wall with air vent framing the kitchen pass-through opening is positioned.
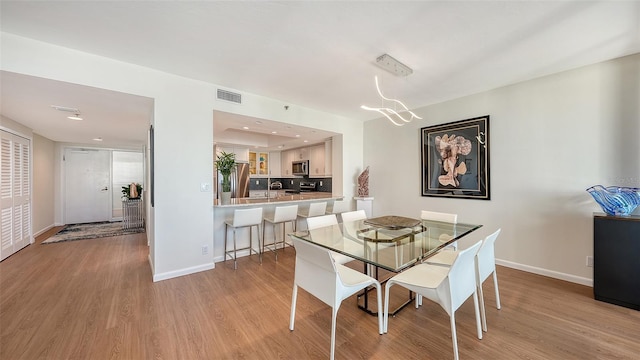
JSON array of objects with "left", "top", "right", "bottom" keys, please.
[{"left": 0, "top": 33, "right": 363, "bottom": 281}]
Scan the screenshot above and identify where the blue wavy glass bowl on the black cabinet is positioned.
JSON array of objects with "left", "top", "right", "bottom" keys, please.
[{"left": 587, "top": 185, "right": 640, "bottom": 216}]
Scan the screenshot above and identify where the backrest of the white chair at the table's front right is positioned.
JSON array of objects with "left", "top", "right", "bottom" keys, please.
[{"left": 438, "top": 241, "right": 482, "bottom": 316}]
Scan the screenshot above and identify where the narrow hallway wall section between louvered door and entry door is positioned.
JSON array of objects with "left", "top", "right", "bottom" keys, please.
[{"left": 31, "top": 134, "right": 55, "bottom": 236}]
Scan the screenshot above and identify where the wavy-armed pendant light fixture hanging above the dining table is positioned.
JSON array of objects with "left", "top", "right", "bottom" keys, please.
[{"left": 360, "top": 54, "right": 422, "bottom": 126}]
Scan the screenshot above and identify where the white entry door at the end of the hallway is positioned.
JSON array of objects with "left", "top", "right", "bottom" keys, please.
[{"left": 64, "top": 148, "right": 112, "bottom": 224}]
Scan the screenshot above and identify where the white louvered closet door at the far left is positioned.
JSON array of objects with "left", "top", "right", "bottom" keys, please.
[{"left": 0, "top": 131, "right": 31, "bottom": 260}]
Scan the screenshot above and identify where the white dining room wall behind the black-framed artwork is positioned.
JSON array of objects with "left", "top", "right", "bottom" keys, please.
[{"left": 364, "top": 54, "right": 640, "bottom": 284}]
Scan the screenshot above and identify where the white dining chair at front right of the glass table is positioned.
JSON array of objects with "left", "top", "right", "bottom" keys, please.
[{"left": 384, "top": 241, "right": 482, "bottom": 360}]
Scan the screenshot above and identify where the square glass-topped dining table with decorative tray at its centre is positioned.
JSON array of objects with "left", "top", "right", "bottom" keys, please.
[{"left": 289, "top": 216, "right": 482, "bottom": 314}]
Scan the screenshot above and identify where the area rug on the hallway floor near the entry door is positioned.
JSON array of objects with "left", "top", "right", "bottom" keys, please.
[{"left": 42, "top": 222, "right": 144, "bottom": 244}]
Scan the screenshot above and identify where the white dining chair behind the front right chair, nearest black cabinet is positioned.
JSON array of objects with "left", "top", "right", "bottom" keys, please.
[{"left": 426, "top": 229, "right": 502, "bottom": 331}]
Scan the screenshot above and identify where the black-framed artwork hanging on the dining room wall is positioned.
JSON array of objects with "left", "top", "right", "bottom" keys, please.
[{"left": 420, "top": 115, "right": 491, "bottom": 200}]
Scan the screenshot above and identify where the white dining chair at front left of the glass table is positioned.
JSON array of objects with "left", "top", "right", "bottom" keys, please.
[{"left": 289, "top": 237, "right": 383, "bottom": 359}]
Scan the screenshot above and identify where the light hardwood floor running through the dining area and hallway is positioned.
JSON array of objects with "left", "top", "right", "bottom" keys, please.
[{"left": 0, "top": 229, "right": 640, "bottom": 359}]
